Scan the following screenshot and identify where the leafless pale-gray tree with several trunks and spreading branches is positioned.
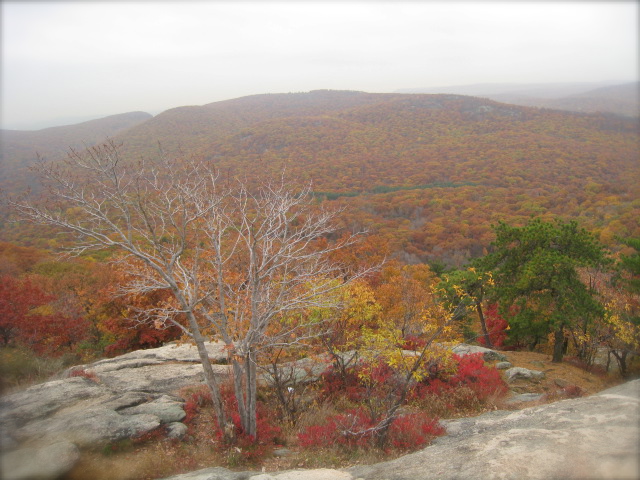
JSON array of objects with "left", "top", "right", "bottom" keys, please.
[{"left": 11, "top": 142, "right": 365, "bottom": 440}]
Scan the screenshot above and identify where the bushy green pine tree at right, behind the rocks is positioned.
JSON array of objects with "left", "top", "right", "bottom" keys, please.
[{"left": 483, "top": 219, "right": 606, "bottom": 360}]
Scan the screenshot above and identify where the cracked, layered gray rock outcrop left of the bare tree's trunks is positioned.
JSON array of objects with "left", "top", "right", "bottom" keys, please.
[{"left": 0, "top": 343, "right": 228, "bottom": 479}]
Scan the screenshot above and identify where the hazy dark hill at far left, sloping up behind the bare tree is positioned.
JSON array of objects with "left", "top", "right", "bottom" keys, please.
[{"left": 0, "top": 112, "right": 152, "bottom": 191}]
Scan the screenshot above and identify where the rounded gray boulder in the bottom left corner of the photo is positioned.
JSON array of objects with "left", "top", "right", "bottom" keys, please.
[{"left": 0, "top": 442, "right": 80, "bottom": 480}]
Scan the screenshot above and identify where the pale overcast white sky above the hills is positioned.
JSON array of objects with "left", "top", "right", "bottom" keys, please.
[{"left": 0, "top": 0, "right": 638, "bottom": 129}]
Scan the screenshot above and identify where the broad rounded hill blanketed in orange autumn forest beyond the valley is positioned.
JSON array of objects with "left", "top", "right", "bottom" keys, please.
[{"left": 3, "top": 91, "right": 640, "bottom": 265}]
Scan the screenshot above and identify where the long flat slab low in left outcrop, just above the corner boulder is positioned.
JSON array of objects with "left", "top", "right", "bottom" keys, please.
[{"left": 15, "top": 407, "right": 160, "bottom": 447}]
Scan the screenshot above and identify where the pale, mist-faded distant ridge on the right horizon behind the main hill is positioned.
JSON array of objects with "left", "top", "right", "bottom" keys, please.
[{"left": 399, "top": 82, "right": 640, "bottom": 117}]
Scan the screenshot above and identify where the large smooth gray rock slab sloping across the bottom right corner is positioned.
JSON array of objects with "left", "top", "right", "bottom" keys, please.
[{"left": 347, "top": 380, "right": 640, "bottom": 480}]
